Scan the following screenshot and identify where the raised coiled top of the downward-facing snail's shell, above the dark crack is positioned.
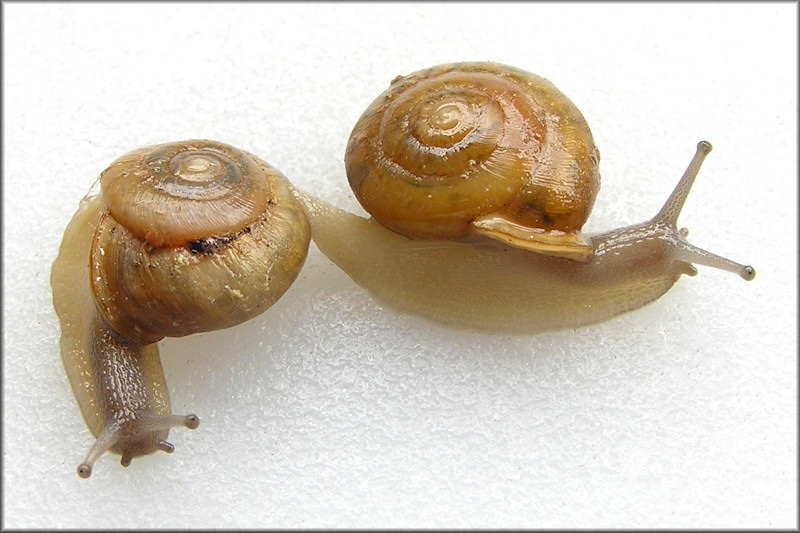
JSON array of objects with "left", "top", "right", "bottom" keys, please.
[{"left": 100, "top": 140, "right": 271, "bottom": 247}]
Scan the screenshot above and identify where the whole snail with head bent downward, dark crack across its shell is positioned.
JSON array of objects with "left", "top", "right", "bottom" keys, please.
[{"left": 51, "top": 140, "right": 310, "bottom": 478}]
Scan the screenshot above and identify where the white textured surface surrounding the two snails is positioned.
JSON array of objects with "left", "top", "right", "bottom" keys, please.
[{"left": 3, "top": 3, "right": 798, "bottom": 528}]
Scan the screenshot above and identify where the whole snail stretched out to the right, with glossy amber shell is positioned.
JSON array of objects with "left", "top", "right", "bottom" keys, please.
[{"left": 295, "top": 63, "right": 755, "bottom": 333}]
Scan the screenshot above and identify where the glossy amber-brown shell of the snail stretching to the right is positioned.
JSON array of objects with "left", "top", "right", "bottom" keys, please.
[{"left": 345, "top": 63, "right": 599, "bottom": 243}]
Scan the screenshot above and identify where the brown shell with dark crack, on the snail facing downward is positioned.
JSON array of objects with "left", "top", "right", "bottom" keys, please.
[{"left": 90, "top": 141, "right": 310, "bottom": 344}]
